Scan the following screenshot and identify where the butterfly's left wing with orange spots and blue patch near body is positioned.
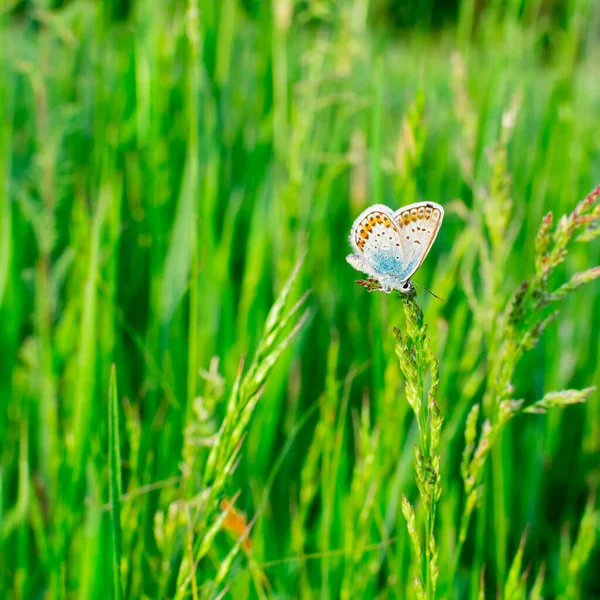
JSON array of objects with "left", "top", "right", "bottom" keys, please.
[{"left": 347, "top": 204, "right": 410, "bottom": 280}]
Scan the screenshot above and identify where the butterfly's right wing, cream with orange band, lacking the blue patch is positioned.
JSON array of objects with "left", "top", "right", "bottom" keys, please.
[{"left": 394, "top": 202, "right": 444, "bottom": 278}]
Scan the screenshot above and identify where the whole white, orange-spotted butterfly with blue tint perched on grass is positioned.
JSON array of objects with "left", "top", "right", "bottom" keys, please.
[{"left": 346, "top": 202, "right": 444, "bottom": 294}]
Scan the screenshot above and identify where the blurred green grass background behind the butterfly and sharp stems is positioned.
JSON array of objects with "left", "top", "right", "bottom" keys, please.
[{"left": 0, "top": 0, "right": 600, "bottom": 599}]
